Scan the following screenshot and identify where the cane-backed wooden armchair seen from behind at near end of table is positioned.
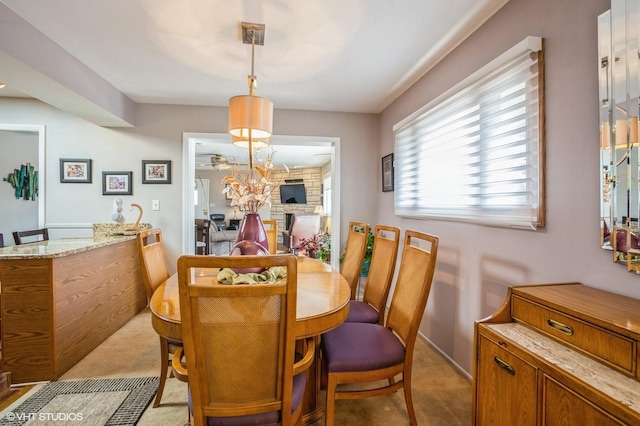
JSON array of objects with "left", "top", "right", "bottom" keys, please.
[{"left": 173, "top": 254, "right": 315, "bottom": 425}]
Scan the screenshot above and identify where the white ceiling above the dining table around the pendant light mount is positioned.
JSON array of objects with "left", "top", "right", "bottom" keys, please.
[{"left": 0, "top": 0, "right": 508, "bottom": 167}]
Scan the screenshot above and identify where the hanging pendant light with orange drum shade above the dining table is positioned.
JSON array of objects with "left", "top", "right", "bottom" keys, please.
[{"left": 229, "top": 22, "right": 273, "bottom": 167}]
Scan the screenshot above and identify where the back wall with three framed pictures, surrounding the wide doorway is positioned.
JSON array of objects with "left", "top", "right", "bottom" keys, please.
[{"left": 0, "top": 98, "right": 379, "bottom": 270}]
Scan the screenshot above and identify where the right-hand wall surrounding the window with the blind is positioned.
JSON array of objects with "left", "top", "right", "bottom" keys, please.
[{"left": 378, "top": 0, "right": 624, "bottom": 374}]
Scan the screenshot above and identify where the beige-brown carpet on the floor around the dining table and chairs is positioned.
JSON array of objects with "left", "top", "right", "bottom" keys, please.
[{"left": 23, "top": 309, "right": 471, "bottom": 426}]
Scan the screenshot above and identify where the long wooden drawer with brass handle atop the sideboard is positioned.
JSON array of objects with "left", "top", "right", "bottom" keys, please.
[{"left": 511, "top": 295, "right": 636, "bottom": 376}]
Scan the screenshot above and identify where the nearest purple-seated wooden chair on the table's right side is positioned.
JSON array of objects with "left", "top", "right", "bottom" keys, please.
[{"left": 320, "top": 231, "right": 438, "bottom": 426}]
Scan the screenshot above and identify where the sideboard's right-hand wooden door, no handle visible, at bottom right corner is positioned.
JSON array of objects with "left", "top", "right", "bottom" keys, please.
[{"left": 542, "top": 374, "right": 624, "bottom": 426}]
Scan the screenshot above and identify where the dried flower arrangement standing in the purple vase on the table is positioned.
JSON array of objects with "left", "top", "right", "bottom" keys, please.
[{"left": 222, "top": 151, "right": 275, "bottom": 213}]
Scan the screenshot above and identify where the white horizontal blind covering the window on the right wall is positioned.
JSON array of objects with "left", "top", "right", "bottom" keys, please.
[{"left": 393, "top": 37, "right": 544, "bottom": 229}]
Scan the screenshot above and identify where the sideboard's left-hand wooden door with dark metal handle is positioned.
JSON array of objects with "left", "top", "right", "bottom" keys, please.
[{"left": 476, "top": 335, "right": 537, "bottom": 426}]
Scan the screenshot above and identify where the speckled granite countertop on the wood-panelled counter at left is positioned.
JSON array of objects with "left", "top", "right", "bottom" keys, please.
[{"left": 0, "top": 235, "right": 136, "bottom": 261}]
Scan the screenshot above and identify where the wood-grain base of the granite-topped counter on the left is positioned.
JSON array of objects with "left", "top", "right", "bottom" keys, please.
[{"left": 0, "top": 239, "right": 146, "bottom": 383}]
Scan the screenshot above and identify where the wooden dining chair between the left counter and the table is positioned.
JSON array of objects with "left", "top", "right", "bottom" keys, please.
[{"left": 137, "top": 228, "right": 176, "bottom": 408}]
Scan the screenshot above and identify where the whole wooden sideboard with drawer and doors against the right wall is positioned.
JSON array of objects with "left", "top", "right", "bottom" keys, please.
[{"left": 473, "top": 283, "right": 640, "bottom": 426}]
